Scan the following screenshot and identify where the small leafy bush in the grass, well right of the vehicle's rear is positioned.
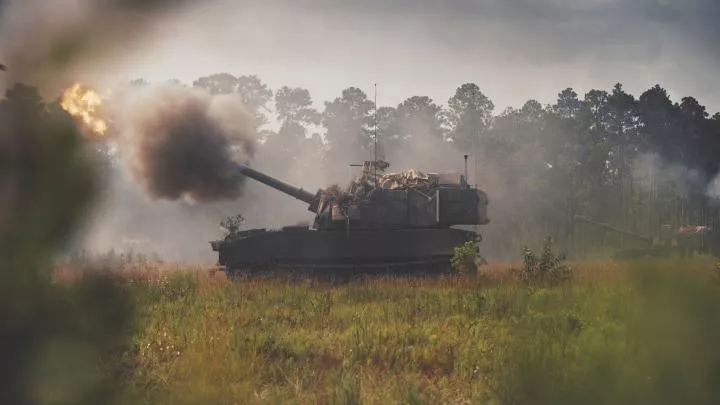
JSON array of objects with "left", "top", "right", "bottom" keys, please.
[{"left": 515, "top": 237, "right": 572, "bottom": 285}]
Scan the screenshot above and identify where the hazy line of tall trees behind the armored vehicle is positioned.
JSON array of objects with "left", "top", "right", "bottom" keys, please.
[{"left": 8, "top": 73, "right": 720, "bottom": 255}]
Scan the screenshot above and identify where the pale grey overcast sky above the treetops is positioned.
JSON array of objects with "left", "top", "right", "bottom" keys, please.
[{"left": 8, "top": 0, "right": 720, "bottom": 112}]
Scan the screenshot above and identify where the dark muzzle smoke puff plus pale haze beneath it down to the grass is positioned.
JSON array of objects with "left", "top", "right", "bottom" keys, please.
[{"left": 69, "top": 84, "right": 256, "bottom": 262}]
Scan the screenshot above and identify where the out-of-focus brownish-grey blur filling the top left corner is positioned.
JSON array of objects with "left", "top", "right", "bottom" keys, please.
[{"left": 0, "top": 0, "right": 194, "bottom": 97}]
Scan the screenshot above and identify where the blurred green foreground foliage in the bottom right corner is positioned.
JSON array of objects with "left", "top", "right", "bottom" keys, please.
[{"left": 497, "top": 263, "right": 720, "bottom": 405}]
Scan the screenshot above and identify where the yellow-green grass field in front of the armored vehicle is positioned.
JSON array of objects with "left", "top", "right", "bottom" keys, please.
[{"left": 58, "top": 260, "right": 720, "bottom": 404}]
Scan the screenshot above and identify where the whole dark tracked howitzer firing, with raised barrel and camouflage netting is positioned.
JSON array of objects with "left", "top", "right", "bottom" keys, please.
[{"left": 211, "top": 161, "right": 489, "bottom": 276}]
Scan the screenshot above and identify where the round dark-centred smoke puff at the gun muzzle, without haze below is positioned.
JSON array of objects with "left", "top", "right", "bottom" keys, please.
[{"left": 120, "top": 85, "right": 255, "bottom": 202}]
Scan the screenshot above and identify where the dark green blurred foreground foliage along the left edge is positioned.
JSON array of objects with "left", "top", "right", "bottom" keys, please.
[{"left": 0, "top": 84, "right": 132, "bottom": 405}]
